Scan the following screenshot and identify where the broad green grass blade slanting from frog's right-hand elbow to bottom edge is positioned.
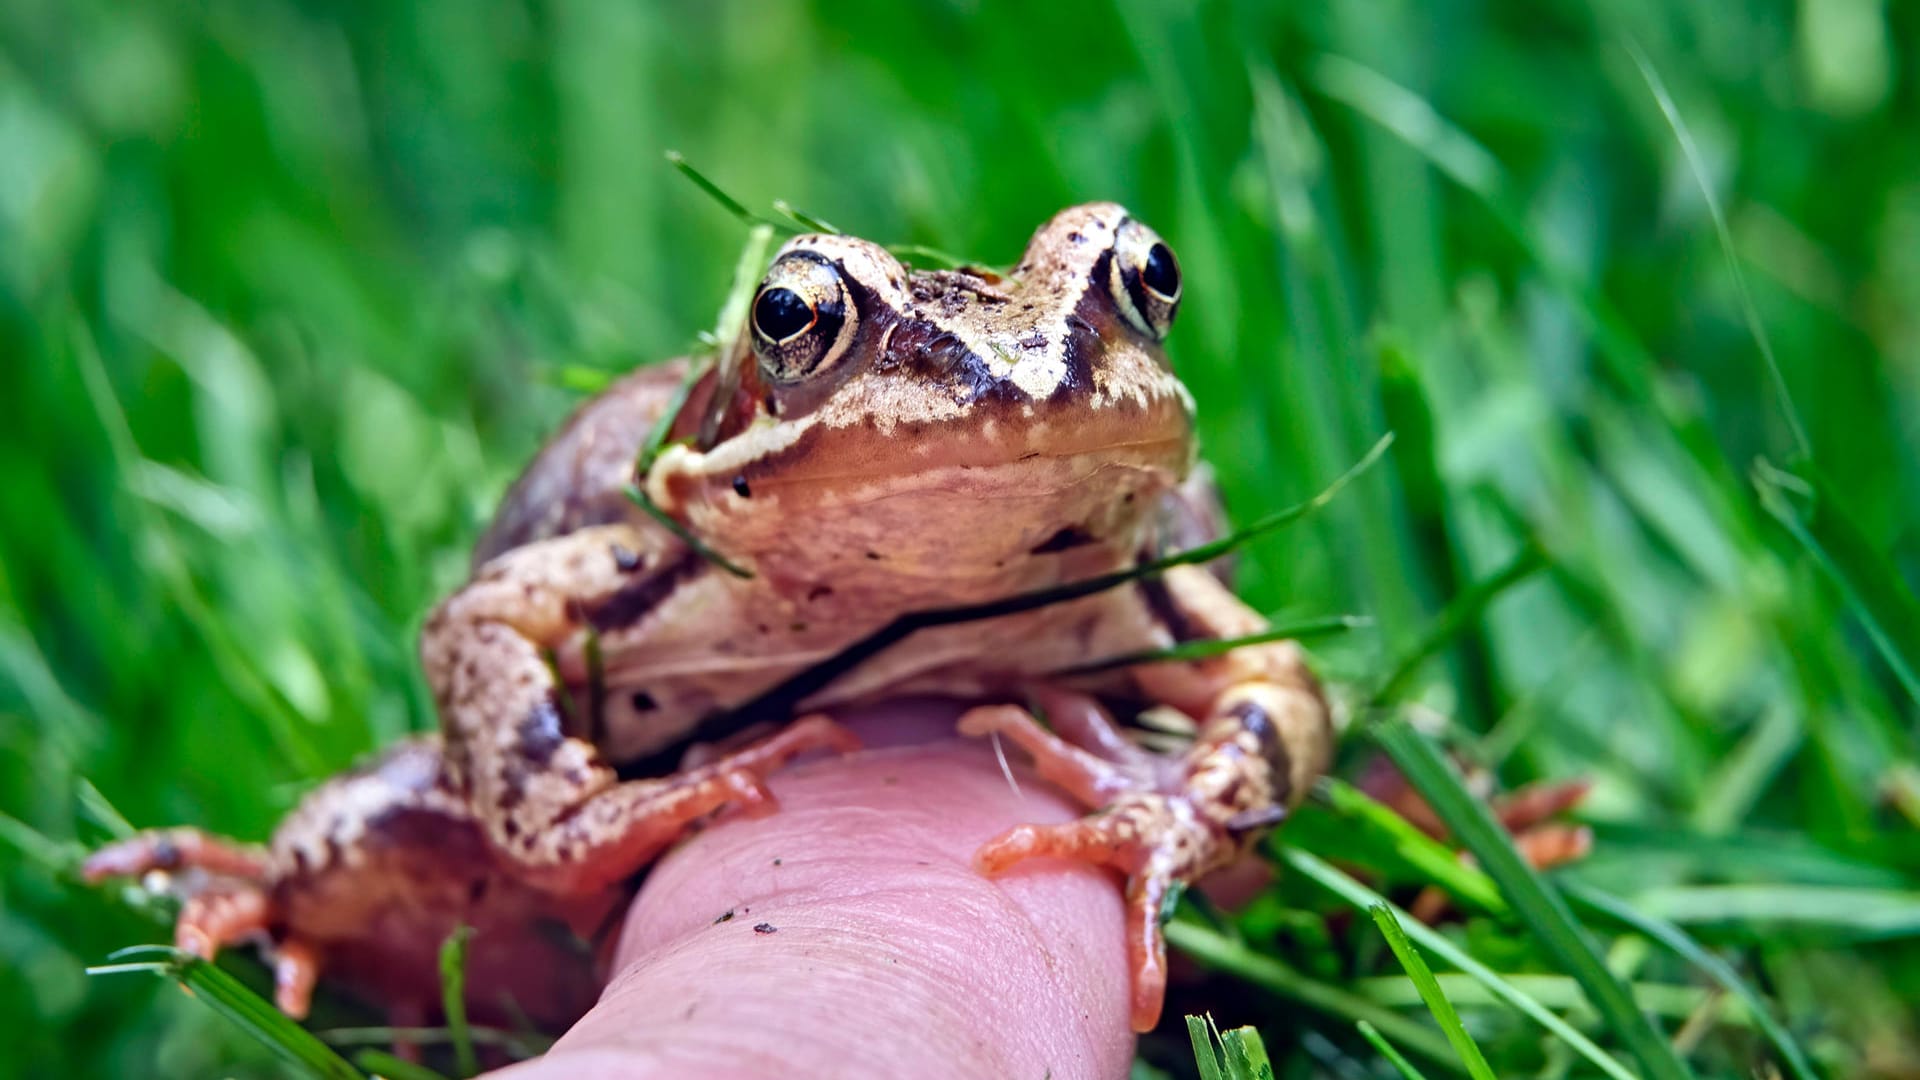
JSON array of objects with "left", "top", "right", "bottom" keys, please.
[{"left": 1373, "top": 719, "right": 1692, "bottom": 1080}]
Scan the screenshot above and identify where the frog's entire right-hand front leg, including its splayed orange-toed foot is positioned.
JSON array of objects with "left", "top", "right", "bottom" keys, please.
[{"left": 960, "top": 567, "right": 1332, "bottom": 1032}]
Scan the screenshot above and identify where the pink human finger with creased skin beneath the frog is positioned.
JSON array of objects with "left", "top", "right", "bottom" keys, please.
[{"left": 509, "top": 717, "right": 1133, "bottom": 1080}]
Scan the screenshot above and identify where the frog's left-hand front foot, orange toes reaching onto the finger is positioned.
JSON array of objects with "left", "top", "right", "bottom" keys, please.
[{"left": 493, "top": 715, "right": 860, "bottom": 894}]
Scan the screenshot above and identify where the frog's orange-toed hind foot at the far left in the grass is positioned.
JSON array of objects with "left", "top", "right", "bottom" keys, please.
[{"left": 81, "top": 828, "right": 319, "bottom": 1019}]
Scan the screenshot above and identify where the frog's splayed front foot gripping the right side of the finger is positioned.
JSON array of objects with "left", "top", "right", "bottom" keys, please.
[{"left": 960, "top": 682, "right": 1323, "bottom": 1032}]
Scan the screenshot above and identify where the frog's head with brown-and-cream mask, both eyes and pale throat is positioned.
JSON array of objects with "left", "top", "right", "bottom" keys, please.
[{"left": 647, "top": 204, "right": 1194, "bottom": 601}]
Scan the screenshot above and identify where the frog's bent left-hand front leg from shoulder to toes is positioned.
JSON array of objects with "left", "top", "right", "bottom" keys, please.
[{"left": 432, "top": 525, "right": 856, "bottom": 894}]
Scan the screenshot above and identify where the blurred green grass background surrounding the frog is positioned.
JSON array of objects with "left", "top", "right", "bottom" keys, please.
[{"left": 0, "top": 0, "right": 1920, "bottom": 1076}]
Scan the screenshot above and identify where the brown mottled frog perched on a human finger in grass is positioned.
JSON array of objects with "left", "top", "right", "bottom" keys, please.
[{"left": 84, "top": 202, "right": 1332, "bottom": 1032}]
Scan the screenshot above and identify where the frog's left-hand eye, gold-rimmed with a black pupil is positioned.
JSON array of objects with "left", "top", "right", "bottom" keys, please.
[{"left": 753, "top": 252, "right": 856, "bottom": 382}]
